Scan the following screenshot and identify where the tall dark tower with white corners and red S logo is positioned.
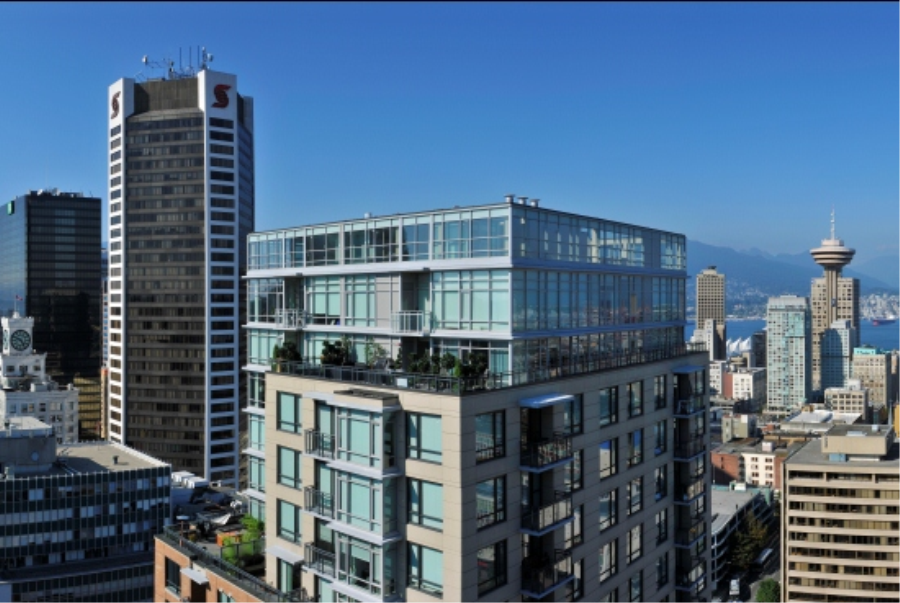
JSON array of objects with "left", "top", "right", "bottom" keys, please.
[{"left": 111, "top": 57, "right": 254, "bottom": 485}]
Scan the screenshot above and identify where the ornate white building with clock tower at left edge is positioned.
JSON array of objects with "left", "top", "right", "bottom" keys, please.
[{"left": 0, "top": 311, "right": 79, "bottom": 444}]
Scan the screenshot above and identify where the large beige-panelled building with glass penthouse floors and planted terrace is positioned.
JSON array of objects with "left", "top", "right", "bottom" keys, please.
[{"left": 245, "top": 201, "right": 710, "bottom": 603}]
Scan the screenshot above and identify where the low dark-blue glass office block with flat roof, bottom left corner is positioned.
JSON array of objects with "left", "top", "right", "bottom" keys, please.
[{"left": 0, "top": 417, "right": 171, "bottom": 603}]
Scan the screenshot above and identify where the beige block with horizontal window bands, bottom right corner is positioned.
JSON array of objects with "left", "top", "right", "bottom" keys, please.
[{"left": 781, "top": 425, "right": 900, "bottom": 603}]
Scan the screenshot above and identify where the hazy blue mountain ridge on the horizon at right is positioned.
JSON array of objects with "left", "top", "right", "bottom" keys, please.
[{"left": 687, "top": 240, "right": 900, "bottom": 297}]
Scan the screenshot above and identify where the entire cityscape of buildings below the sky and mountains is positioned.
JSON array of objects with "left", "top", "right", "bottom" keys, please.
[{"left": 0, "top": 44, "right": 900, "bottom": 603}]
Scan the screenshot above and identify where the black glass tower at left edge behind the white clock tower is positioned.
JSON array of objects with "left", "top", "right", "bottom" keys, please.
[{"left": 0, "top": 189, "right": 103, "bottom": 440}]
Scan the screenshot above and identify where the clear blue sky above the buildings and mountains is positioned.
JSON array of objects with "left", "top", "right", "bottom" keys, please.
[{"left": 0, "top": 2, "right": 900, "bottom": 261}]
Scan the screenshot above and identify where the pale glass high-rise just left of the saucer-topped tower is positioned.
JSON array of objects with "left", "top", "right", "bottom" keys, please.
[{"left": 766, "top": 295, "right": 811, "bottom": 416}]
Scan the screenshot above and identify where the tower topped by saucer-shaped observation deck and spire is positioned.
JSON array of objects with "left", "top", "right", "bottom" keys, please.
[{"left": 810, "top": 212, "right": 859, "bottom": 391}]
